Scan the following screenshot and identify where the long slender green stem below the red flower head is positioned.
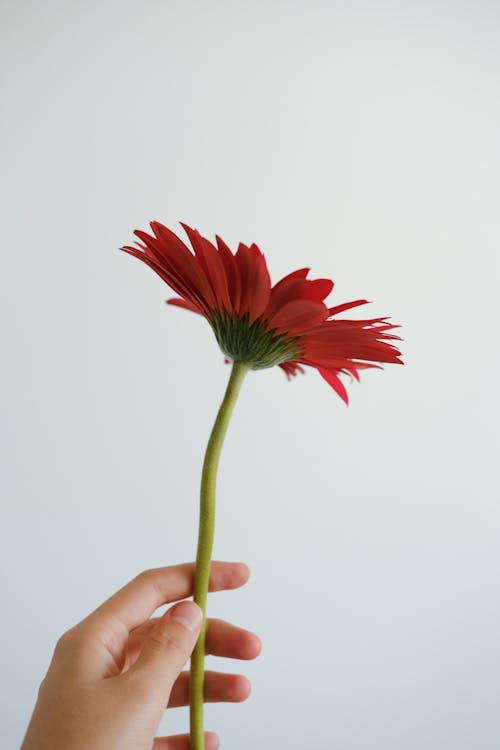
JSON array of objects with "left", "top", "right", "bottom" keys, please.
[{"left": 189, "top": 362, "right": 248, "bottom": 750}]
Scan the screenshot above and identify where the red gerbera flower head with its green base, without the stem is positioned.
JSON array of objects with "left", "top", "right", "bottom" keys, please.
[{"left": 122, "top": 221, "right": 402, "bottom": 403}]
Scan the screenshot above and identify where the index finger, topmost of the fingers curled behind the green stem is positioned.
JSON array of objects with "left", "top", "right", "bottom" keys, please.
[{"left": 86, "top": 561, "right": 250, "bottom": 635}]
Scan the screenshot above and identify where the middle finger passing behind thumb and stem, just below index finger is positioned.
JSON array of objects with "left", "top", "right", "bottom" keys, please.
[{"left": 123, "top": 618, "right": 262, "bottom": 671}]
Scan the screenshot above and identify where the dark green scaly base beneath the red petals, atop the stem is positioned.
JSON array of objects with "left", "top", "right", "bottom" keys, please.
[{"left": 210, "top": 313, "right": 300, "bottom": 370}]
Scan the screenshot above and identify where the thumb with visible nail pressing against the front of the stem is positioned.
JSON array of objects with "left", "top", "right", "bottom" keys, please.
[{"left": 128, "top": 601, "right": 202, "bottom": 700}]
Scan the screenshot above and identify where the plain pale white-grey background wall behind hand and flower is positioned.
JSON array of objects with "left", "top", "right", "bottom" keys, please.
[{"left": 1, "top": 0, "right": 500, "bottom": 750}]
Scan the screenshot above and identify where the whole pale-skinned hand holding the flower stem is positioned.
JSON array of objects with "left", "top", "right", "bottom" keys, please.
[{"left": 21, "top": 562, "right": 260, "bottom": 750}]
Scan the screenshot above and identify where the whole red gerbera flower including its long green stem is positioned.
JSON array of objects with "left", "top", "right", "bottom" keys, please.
[{"left": 122, "top": 221, "right": 401, "bottom": 750}]
